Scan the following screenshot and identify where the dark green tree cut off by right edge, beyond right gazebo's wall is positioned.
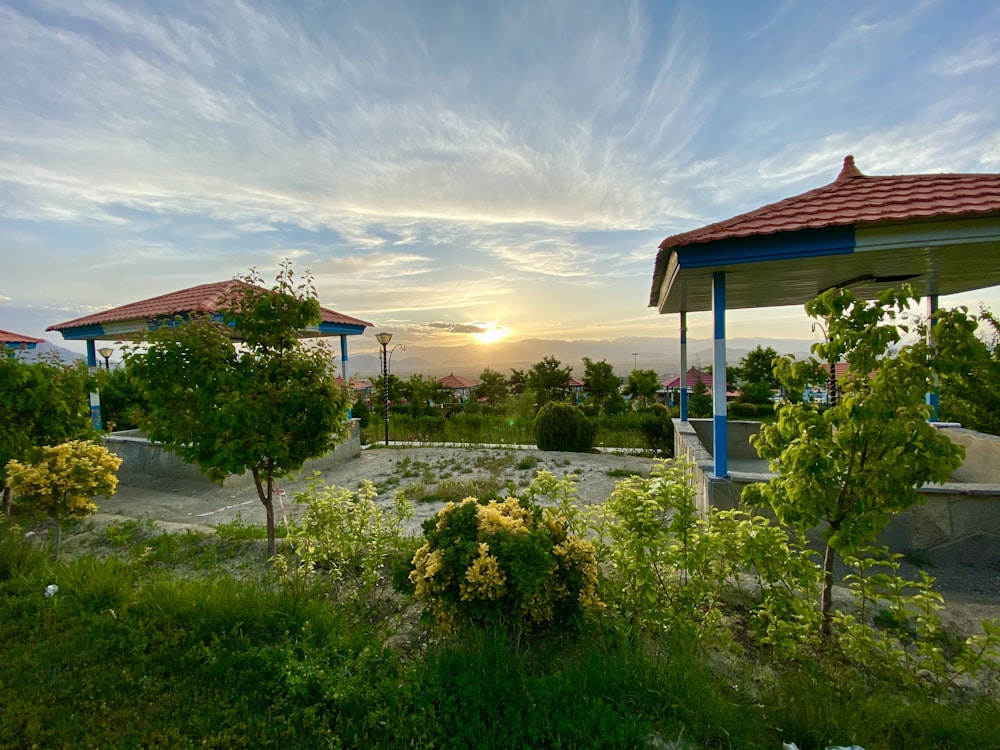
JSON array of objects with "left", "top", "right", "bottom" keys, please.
[{"left": 940, "top": 309, "right": 1000, "bottom": 435}]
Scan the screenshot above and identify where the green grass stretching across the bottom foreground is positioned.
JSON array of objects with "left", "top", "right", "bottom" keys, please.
[{"left": 0, "top": 521, "right": 1000, "bottom": 750}]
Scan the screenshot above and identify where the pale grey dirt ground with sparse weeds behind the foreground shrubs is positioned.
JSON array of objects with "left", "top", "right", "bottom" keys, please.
[{"left": 84, "top": 447, "right": 1000, "bottom": 632}]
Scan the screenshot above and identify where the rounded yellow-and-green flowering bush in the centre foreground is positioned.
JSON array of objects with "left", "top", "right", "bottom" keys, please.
[{"left": 410, "top": 479, "right": 604, "bottom": 634}]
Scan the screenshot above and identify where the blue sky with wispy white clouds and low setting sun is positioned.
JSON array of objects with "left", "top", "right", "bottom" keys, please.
[{"left": 0, "top": 0, "right": 1000, "bottom": 350}]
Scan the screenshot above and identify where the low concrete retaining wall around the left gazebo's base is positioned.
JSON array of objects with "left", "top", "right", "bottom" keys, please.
[{"left": 104, "top": 419, "right": 361, "bottom": 487}]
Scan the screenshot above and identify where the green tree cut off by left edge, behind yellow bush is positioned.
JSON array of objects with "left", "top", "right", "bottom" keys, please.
[{"left": 0, "top": 356, "right": 97, "bottom": 515}]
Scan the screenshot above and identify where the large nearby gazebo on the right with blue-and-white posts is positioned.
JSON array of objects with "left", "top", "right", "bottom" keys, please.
[{"left": 649, "top": 156, "right": 1000, "bottom": 479}]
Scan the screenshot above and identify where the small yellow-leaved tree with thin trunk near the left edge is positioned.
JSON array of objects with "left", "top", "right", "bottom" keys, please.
[{"left": 6, "top": 440, "right": 122, "bottom": 557}]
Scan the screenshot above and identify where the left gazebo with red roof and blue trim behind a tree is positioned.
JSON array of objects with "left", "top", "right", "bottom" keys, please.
[{"left": 46, "top": 279, "right": 372, "bottom": 429}]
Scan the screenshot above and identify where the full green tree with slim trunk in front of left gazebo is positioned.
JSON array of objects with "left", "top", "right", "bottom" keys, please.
[{"left": 125, "top": 263, "right": 349, "bottom": 555}]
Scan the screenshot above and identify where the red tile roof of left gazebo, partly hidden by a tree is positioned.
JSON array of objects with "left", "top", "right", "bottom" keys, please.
[{"left": 46, "top": 279, "right": 371, "bottom": 331}]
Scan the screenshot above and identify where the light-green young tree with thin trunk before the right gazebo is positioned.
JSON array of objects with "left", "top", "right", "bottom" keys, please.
[{"left": 743, "top": 287, "right": 978, "bottom": 635}]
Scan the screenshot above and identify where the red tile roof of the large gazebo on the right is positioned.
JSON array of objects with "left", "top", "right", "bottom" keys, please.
[{"left": 660, "top": 156, "right": 1000, "bottom": 249}]
